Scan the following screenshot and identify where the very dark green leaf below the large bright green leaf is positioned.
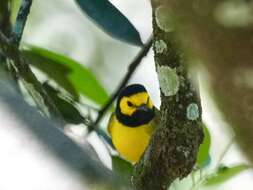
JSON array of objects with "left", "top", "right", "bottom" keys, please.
[{"left": 43, "top": 82, "right": 84, "bottom": 125}]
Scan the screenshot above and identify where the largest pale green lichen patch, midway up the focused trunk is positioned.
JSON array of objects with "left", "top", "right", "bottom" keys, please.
[{"left": 157, "top": 65, "right": 180, "bottom": 96}]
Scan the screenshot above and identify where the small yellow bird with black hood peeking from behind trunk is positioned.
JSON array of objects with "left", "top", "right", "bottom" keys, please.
[{"left": 108, "top": 84, "right": 157, "bottom": 163}]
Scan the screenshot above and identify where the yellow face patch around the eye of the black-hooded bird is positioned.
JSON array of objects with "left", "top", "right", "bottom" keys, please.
[{"left": 119, "top": 92, "right": 153, "bottom": 116}]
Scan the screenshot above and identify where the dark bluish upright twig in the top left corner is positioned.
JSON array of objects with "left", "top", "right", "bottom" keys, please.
[{"left": 10, "top": 0, "right": 32, "bottom": 47}]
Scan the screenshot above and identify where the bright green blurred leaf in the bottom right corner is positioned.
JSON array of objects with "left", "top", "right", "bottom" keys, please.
[{"left": 204, "top": 164, "right": 250, "bottom": 185}]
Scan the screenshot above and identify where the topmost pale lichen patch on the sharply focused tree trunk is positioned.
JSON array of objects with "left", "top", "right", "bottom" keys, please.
[{"left": 155, "top": 5, "right": 174, "bottom": 32}]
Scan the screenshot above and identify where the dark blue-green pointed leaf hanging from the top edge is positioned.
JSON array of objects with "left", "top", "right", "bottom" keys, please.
[{"left": 76, "top": 0, "right": 143, "bottom": 46}]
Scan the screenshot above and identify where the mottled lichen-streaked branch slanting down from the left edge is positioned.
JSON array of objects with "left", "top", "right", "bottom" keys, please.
[{"left": 0, "top": 31, "right": 63, "bottom": 124}]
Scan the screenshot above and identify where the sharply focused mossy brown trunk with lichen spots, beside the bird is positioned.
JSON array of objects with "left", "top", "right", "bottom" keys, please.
[{"left": 132, "top": 1, "right": 203, "bottom": 190}]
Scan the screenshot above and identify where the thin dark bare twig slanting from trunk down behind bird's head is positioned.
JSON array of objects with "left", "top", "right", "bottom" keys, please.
[{"left": 93, "top": 37, "right": 153, "bottom": 128}]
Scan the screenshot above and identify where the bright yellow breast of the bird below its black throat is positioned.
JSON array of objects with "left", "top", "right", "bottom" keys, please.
[{"left": 108, "top": 116, "right": 154, "bottom": 163}]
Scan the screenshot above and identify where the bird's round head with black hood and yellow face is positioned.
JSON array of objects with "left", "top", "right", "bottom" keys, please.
[{"left": 116, "top": 84, "right": 155, "bottom": 127}]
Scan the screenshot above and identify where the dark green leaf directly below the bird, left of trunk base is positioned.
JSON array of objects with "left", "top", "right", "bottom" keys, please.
[{"left": 112, "top": 156, "right": 133, "bottom": 183}]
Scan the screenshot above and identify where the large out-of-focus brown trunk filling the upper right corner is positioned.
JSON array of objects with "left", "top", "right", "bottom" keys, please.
[{"left": 152, "top": 0, "right": 253, "bottom": 163}]
